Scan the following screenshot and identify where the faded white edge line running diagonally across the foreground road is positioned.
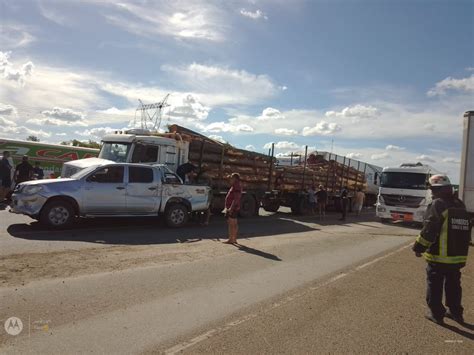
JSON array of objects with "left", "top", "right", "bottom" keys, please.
[{"left": 165, "top": 242, "right": 412, "bottom": 355}]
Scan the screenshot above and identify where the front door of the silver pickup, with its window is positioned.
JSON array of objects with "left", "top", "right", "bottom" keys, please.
[{"left": 82, "top": 165, "right": 127, "bottom": 215}]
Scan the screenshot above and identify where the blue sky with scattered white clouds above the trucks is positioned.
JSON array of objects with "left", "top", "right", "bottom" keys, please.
[{"left": 0, "top": 0, "right": 474, "bottom": 182}]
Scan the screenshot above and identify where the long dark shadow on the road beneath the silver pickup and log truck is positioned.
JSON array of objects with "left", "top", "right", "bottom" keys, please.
[{"left": 7, "top": 212, "right": 382, "bottom": 246}]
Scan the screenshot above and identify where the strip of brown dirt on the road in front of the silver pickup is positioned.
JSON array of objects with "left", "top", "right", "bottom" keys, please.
[{"left": 0, "top": 239, "right": 234, "bottom": 287}]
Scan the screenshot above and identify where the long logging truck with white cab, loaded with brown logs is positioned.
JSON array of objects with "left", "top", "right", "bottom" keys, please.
[{"left": 61, "top": 125, "right": 367, "bottom": 217}]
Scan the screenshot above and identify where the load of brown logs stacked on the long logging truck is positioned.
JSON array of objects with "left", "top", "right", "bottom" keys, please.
[{"left": 169, "top": 125, "right": 366, "bottom": 192}]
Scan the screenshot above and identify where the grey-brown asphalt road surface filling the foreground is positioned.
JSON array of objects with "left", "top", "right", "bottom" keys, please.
[{"left": 0, "top": 207, "right": 472, "bottom": 354}]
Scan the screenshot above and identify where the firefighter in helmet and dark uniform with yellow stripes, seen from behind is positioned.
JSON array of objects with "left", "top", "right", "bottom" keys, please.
[{"left": 413, "top": 175, "right": 472, "bottom": 325}]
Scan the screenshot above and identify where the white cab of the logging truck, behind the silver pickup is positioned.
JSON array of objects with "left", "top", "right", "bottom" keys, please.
[{"left": 61, "top": 129, "right": 189, "bottom": 177}]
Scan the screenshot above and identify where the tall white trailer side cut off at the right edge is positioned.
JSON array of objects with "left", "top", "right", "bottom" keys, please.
[{"left": 459, "top": 111, "right": 474, "bottom": 217}]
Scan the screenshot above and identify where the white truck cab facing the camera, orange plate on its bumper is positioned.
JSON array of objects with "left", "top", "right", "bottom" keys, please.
[{"left": 376, "top": 163, "right": 438, "bottom": 222}]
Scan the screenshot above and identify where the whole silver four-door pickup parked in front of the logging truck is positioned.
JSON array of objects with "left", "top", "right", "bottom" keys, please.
[{"left": 10, "top": 162, "right": 210, "bottom": 228}]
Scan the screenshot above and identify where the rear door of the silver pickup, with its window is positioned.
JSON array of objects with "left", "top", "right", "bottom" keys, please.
[{"left": 126, "top": 166, "right": 161, "bottom": 214}]
